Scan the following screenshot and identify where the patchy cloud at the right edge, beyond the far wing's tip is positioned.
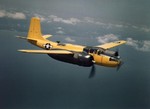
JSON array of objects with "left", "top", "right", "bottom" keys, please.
[{"left": 127, "top": 38, "right": 150, "bottom": 52}]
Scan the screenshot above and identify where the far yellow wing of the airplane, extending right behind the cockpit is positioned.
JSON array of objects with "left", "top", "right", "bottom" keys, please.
[{"left": 96, "top": 40, "right": 126, "bottom": 49}]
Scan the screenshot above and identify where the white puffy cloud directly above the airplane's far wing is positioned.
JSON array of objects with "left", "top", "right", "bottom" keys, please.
[{"left": 96, "top": 34, "right": 119, "bottom": 44}]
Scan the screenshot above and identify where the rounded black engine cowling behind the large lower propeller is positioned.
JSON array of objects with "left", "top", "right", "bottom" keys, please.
[{"left": 73, "top": 52, "right": 93, "bottom": 67}]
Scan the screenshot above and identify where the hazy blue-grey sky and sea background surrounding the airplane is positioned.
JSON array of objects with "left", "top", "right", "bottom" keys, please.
[{"left": 0, "top": 0, "right": 150, "bottom": 109}]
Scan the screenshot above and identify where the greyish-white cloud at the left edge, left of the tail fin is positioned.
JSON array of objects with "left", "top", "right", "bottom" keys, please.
[{"left": 0, "top": 10, "right": 26, "bottom": 19}]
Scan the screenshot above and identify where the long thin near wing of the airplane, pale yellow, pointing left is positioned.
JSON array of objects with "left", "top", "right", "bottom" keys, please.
[{"left": 18, "top": 50, "right": 73, "bottom": 54}]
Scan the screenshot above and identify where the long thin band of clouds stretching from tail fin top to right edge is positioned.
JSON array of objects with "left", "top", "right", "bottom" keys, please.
[{"left": 31, "top": 14, "right": 150, "bottom": 32}]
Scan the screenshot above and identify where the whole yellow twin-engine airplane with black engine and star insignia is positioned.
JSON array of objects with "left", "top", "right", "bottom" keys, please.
[{"left": 18, "top": 17, "right": 126, "bottom": 77}]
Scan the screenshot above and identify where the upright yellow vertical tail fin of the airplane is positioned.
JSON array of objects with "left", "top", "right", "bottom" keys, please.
[{"left": 27, "top": 17, "right": 45, "bottom": 40}]
